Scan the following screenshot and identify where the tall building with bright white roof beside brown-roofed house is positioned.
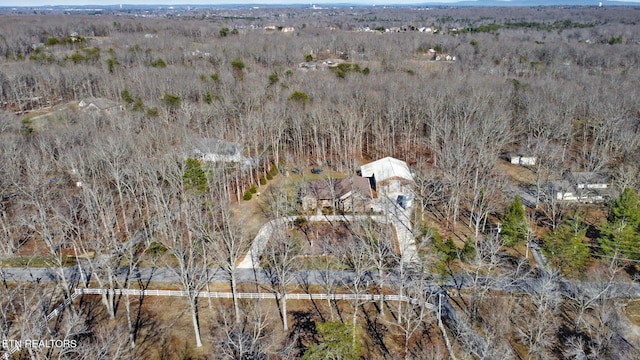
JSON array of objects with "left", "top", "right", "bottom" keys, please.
[{"left": 360, "top": 157, "right": 414, "bottom": 194}]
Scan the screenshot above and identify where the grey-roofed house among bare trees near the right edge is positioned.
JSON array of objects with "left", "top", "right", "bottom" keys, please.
[{"left": 549, "top": 172, "right": 612, "bottom": 203}]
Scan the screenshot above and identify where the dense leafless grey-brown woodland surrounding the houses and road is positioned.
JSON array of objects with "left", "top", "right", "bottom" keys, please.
[{"left": 0, "top": 7, "right": 640, "bottom": 359}]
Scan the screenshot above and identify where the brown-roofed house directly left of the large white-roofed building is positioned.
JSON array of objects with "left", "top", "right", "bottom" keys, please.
[{"left": 300, "top": 176, "right": 373, "bottom": 212}]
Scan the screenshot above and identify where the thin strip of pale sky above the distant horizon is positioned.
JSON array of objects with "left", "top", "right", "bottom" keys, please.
[{"left": 0, "top": 0, "right": 640, "bottom": 6}]
